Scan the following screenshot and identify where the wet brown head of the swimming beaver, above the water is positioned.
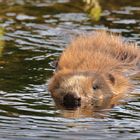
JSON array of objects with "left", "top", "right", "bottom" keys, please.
[{"left": 49, "top": 71, "right": 128, "bottom": 107}]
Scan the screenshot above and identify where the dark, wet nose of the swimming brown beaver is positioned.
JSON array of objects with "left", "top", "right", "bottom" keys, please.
[{"left": 63, "top": 93, "right": 81, "bottom": 108}]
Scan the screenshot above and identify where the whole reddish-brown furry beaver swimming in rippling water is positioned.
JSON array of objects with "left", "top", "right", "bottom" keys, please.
[{"left": 48, "top": 31, "right": 140, "bottom": 107}]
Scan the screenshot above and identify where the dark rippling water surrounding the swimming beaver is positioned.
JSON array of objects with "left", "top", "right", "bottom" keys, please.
[{"left": 0, "top": 0, "right": 140, "bottom": 140}]
